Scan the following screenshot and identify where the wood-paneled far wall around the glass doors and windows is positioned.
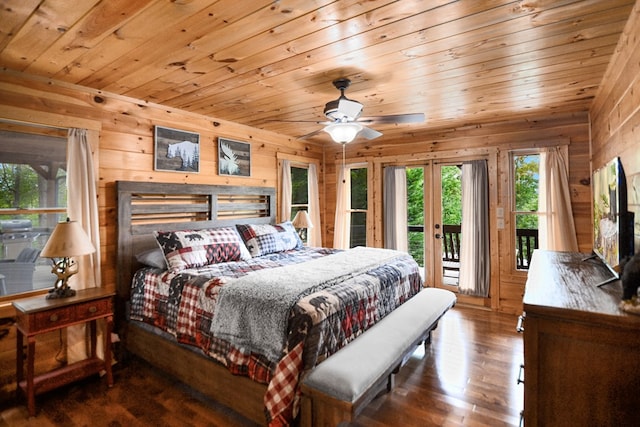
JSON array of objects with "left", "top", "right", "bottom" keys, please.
[{"left": 324, "top": 112, "right": 592, "bottom": 313}]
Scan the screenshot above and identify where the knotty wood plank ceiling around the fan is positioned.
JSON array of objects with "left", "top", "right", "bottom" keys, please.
[{"left": 0, "top": 0, "right": 634, "bottom": 142}]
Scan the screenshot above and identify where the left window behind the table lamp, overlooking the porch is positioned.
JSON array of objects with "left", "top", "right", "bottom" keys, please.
[{"left": 0, "top": 131, "right": 67, "bottom": 298}]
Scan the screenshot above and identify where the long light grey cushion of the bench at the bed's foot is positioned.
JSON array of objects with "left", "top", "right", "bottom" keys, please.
[{"left": 302, "top": 288, "right": 456, "bottom": 403}]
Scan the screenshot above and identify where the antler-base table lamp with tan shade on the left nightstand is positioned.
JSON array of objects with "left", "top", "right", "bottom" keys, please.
[{"left": 40, "top": 218, "right": 96, "bottom": 299}]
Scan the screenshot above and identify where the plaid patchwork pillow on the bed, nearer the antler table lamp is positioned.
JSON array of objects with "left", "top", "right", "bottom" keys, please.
[{"left": 154, "top": 227, "right": 251, "bottom": 271}]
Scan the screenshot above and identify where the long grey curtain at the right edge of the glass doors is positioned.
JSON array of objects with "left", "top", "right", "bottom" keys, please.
[{"left": 459, "top": 160, "right": 490, "bottom": 297}]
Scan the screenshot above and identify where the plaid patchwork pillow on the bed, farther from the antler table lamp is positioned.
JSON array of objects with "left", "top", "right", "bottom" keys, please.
[{"left": 236, "top": 221, "right": 302, "bottom": 257}]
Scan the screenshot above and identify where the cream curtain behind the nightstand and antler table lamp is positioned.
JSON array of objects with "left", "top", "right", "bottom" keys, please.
[{"left": 67, "top": 129, "right": 104, "bottom": 363}]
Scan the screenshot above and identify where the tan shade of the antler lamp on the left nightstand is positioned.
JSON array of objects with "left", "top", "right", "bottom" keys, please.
[{"left": 40, "top": 219, "right": 96, "bottom": 258}]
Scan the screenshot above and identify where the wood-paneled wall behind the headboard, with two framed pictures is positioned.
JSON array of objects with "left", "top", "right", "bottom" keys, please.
[{"left": 0, "top": 71, "right": 324, "bottom": 300}]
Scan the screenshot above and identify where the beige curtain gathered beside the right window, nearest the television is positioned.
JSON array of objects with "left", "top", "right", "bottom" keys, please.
[{"left": 538, "top": 146, "right": 578, "bottom": 252}]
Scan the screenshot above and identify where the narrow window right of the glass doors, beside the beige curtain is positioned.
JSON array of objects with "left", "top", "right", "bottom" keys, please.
[{"left": 512, "top": 153, "right": 540, "bottom": 270}]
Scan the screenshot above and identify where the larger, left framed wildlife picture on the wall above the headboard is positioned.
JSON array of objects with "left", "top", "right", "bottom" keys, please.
[{"left": 154, "top": 126, "right": 200, "bottom": 173}]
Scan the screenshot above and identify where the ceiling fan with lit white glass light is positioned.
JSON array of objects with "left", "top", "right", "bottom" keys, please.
[{"left": 299, "top": 78, "right": 424, "bottom": 144}]
